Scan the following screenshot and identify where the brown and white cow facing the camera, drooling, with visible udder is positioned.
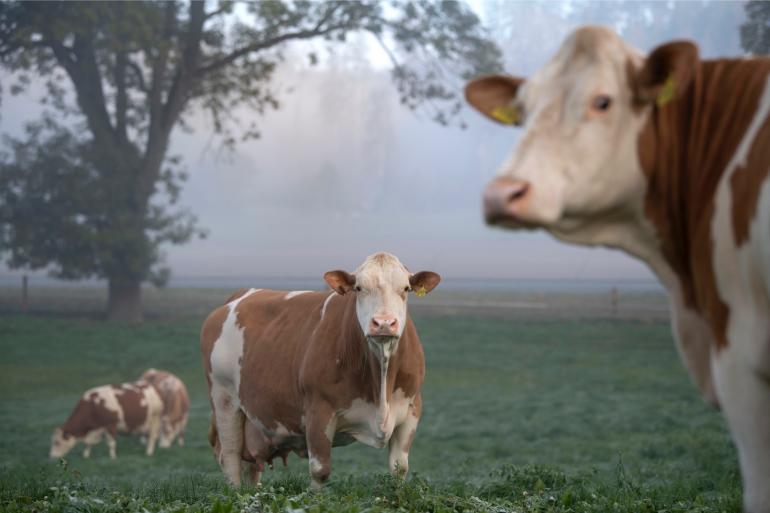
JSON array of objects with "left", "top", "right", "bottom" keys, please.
[{"left": 201, "top": 253, "right": 441, "bottom": 487}]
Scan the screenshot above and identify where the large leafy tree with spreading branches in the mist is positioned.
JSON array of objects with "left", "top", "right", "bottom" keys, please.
[{"left": 0, "top": 0, "right": 500, "bottom": 320}]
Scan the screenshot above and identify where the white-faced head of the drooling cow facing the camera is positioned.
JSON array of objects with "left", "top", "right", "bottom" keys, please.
[{"left": 324, "top": 253, "right": 441, "bottom": 356}]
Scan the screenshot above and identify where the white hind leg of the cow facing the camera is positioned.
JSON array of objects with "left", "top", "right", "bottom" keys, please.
[{"left": 211, "top": 383, "right": 244, "bottom": 486}]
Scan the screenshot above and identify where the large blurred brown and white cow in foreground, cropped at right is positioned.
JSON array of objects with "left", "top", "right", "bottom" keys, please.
[{"left": 466, "top": 27, "right": 770, "bottom": 512}]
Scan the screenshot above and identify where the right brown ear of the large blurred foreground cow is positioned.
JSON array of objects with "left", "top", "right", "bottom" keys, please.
[{"left": 633, "top": 41, "right": 698, "bottom": 107}]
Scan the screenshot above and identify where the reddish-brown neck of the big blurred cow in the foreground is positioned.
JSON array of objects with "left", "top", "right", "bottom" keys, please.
[{"left": 638, "top": 60, "right": 770, "bottom": 347}]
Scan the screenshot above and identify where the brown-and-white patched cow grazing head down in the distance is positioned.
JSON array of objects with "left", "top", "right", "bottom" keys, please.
[{"left": 50, "top": 381, "right": 163, "bottom": 459}]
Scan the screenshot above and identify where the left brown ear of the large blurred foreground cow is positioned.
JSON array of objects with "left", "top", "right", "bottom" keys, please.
[{"left": 465, "top": 75, "right": 524, "bottom": 125}]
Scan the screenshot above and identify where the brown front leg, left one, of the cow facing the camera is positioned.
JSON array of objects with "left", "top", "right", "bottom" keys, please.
[{"left": 305, "top": 403, "right": 337, "bottom": 490}]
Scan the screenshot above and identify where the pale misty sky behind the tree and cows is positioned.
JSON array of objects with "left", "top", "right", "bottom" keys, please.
[{"left": 0, "top": 0, "right": 744, "bottom": 280}]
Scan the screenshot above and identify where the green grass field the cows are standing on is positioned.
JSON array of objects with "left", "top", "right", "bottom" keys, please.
[{"left": 0, "top": 290, "right": 740, "bottom": 513}]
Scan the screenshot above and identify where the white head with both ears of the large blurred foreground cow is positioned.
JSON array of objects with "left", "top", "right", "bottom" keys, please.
[{"left": 465, "top": 27, "right": 698, "bottom": 243}]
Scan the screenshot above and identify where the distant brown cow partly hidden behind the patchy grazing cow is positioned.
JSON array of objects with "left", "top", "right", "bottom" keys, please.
[{"left": 139, "top": 369, "right": 190, "bottom": 449}]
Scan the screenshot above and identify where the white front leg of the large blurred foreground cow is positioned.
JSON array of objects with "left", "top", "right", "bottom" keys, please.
[{"left": 712, "top": 340, "right": 770, "bottom": 513}]
